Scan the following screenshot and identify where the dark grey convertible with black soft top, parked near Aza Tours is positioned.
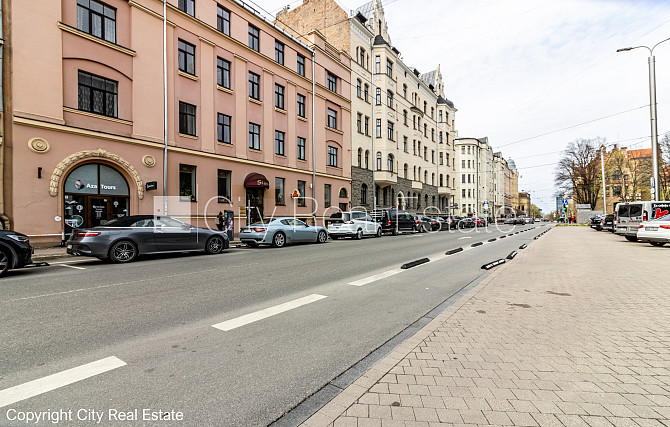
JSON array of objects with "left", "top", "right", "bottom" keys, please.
[{"left": 67, "top": 215, "right": 230, "bottom": 263}]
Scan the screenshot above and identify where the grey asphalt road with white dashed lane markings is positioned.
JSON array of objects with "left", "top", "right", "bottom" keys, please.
[{"left": 0, "top": 224, "right": 547, "bottom": 426}]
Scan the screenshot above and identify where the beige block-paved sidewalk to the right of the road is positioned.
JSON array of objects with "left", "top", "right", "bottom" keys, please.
[{"left": 303, "top": 227, "right": 670, "bottom": 427}]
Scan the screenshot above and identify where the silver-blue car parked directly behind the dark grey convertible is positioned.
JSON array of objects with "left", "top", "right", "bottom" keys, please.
[{"left": 240, "top": 217, "right": 328, "bottom": 248}]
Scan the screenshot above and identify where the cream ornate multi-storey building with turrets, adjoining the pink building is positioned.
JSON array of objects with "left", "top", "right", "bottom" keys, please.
[{"left": 276, "top": 0, "right": 457, "bottom": 212}]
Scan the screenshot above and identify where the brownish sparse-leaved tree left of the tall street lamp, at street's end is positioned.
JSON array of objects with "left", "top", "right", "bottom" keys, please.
[{"left": 555, "top": 137, "right": 605, "bottom": 209}]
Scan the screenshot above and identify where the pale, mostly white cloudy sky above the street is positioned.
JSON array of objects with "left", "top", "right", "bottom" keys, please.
[{"left": 248, "top": 0, "right": 670, "bottom": 213}]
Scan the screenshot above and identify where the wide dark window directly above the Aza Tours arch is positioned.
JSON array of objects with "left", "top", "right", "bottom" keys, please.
[{"left": 78, "top": 71, "right": 118, "bottom": 117}]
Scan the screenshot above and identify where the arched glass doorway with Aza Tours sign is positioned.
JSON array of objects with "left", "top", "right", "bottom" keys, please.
[{"left": 63, "top": 163, "right": 130, "bottom": 231}]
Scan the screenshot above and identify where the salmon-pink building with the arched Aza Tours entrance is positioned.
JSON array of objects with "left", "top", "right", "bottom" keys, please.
[{"left": 0, "top": 0, "right": 352, "bottom": 241}]
